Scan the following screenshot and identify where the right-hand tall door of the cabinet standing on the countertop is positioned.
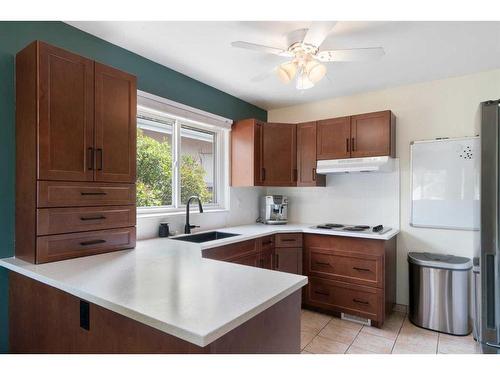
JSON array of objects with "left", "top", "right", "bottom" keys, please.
[{"left": 95, "top": 63, "right": 137, "bottom": 182}]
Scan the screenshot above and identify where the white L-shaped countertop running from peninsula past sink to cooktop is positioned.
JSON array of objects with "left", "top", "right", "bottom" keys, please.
[{"left": 0, "top": 224, "right": 398, "bottom": 346}]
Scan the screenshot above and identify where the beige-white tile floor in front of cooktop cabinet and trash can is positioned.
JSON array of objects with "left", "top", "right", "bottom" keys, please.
[{"left": 301, "top": 310, "right": 479, "bottom": 354}]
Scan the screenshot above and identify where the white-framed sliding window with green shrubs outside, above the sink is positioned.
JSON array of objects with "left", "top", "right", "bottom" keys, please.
[{"left": 137, "top": 92, "right": 228, "bottom": 215}]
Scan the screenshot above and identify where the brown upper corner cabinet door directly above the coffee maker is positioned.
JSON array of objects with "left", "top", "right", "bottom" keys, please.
[{"left": 261, "top": 123, "right": 297, "bottom": 186}]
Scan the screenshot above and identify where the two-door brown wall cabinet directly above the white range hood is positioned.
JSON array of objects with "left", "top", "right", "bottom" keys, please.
[{"left": 317, "top": 111, "right": 396, "bottom": 160}]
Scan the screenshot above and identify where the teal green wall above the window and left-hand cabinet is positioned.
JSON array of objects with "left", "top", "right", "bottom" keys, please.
[{"left": 0, "top": 22, "right": 267, "bottom": 353}]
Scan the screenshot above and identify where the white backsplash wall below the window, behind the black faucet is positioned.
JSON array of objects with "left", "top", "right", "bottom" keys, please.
[{"left": 137, "top": 188, "right": 265, "bottom": 240}]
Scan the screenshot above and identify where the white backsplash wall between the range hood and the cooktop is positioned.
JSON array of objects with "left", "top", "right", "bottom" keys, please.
[{"left": 267, "top": 159, "right": 399, "bottom": 228}]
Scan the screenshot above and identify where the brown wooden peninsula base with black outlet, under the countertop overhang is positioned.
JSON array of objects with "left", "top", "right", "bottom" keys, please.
[{"left": 9, "top": 272, "right": 301, "bottom": 354}]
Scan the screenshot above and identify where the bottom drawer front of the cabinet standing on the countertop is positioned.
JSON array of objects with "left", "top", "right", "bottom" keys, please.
[{"left": 37, "top": 227, "right": 135, "bottom": 263}]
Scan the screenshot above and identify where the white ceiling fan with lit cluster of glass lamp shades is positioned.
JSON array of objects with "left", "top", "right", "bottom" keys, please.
[{"left": 231, "top": 21, "right": 384, "bottom": 90}]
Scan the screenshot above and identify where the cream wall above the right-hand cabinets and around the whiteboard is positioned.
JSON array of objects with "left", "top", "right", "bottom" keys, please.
[{"left": 268, "top": 69, "right": 500, "bottom": 304}]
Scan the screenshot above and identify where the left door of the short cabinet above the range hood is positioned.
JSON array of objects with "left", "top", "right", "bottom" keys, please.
[{"left": 316, "top": 117, "right": 351, "bottom": 160}]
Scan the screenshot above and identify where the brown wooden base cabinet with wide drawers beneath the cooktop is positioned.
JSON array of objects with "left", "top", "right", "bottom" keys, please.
[{"left": 303, "top": 234, "right": 396, "bottom": 327}]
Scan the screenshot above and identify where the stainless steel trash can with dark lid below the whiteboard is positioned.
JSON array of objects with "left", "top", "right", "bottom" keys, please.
[{"left": 408, "top": 252, "right": 472, "bottom": 336}]
